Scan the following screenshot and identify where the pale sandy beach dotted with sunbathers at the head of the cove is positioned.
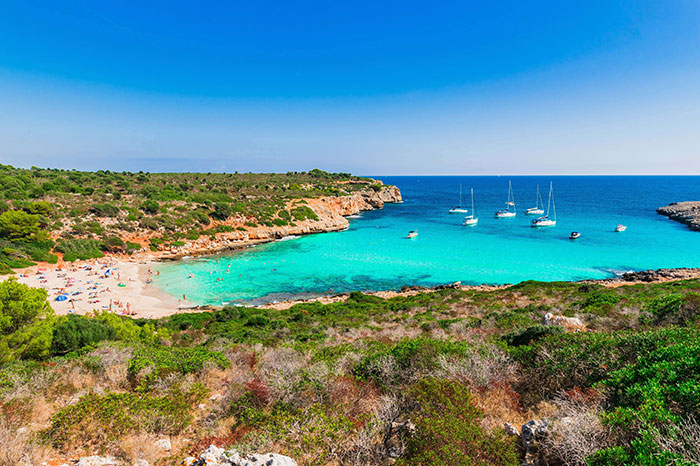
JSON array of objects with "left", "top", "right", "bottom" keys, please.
[{"left": 0, "top": 257, "right": 183, "bottom": 318}]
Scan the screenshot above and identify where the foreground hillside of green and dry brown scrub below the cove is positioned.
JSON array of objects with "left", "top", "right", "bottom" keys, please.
[{"left": 0, "top": 280, "right": 700, "bottom": 466}]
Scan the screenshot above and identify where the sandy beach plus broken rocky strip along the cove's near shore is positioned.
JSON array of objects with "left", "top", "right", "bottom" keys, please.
[{"left": 0, "top": 249, "right": 700, "bottom": 319}]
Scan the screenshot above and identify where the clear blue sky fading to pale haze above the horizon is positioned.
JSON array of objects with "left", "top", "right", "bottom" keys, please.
[{"left": 0, "top": 0, "right": 700, "bottom": 174}]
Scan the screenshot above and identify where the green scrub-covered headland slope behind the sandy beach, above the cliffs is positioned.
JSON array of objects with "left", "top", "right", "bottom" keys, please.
[{"left": 0, "top": 165, "right": 379, "bottom": 273}]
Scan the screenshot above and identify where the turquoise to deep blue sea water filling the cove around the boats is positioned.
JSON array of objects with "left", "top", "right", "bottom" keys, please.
[{"left": 156, "top": 177, "right": 700, "bottom": 304}]
